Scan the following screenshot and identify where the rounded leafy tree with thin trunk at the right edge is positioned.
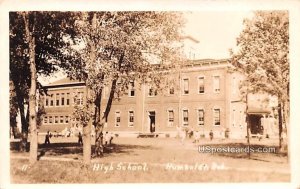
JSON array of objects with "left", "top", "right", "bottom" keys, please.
[{"left": 232, "top": 11, "right": 290, "bottom": 152}]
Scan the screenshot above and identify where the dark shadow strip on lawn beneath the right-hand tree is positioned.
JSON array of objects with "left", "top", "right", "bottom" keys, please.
[{"left": 199, "top": 143, "right": 287, "bottom": 162}]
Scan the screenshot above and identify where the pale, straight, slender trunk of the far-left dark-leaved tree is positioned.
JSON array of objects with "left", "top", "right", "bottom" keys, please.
[{"left": 23, "top": 12, "right": 38, "bottom": 164}]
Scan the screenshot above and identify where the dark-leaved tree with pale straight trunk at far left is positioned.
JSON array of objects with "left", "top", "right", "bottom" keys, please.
[{"left": 9, "top": 12, "right": 77, "bottom": 163}]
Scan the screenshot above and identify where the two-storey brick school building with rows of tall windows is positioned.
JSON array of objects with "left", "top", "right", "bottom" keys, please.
[{"left": 41, "top": 59, "right": 274, "bottom": 138}]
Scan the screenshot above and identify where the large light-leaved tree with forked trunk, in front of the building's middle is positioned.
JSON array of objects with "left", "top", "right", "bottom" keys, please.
[{"left": 62, "top": 12, "right": 182, "bottom": 164}]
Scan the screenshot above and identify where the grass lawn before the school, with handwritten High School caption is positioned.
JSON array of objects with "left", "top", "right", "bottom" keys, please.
[{"left": 10, "top": 138, "right": 290, "bottom": 183}]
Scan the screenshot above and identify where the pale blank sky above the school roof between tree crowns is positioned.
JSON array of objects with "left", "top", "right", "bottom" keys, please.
[{"left": 184, "top": 11, "right": 252, "bottom": 59}]
